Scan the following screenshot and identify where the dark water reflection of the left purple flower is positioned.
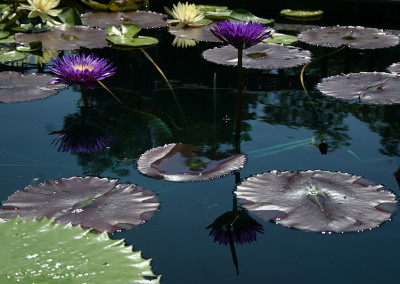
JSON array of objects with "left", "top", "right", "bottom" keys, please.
[{"left": 51, "top": 130, "right": 116, "bottom": 154}]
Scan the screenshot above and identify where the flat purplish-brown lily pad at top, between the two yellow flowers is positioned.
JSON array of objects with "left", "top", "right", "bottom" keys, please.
[{"left": 82, "top": 11, "right": 168, "bottom": 29}]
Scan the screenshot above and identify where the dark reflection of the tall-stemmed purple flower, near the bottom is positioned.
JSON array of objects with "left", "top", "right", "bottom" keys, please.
[{"left": 207, "top": 211, "right": 264, "bottom": 245}]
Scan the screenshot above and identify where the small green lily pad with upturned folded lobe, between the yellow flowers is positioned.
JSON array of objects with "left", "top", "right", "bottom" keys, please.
[{"left": 106, "top": 24, "right": 158, "bottom": 47}]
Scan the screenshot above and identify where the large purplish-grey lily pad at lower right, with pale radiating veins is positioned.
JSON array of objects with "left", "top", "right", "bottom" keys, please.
[{"left": 235, "top": 170, "right": 397, "bottom": 233}]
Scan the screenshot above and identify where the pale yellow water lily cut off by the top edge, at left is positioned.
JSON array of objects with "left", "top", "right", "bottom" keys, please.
[{"left": 18, "top": 0, "right": 61, "bottom": 23}]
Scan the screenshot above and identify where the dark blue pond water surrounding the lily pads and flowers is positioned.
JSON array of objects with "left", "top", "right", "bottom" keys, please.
[{"left": 0, "top": 1, "right": 400, "bottom": 283}]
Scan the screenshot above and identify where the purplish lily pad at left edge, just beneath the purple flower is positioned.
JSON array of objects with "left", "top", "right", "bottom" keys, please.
[{"left": 0, "top": 72, "right": 67, "bottom": 103}]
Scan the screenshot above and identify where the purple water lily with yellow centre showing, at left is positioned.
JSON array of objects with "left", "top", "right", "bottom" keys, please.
[{"left": 48, "top": 54, "right": 116, "bottom": 89}]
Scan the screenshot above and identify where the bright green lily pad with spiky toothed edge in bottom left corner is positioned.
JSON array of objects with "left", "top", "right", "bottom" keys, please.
[{"left": 0, "top": 218, "right": 160, "bottom": 283}]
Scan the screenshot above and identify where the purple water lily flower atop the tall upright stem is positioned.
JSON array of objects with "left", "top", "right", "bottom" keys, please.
[{"left": 211, "top": 21, "right": 271, "bottom": 48}]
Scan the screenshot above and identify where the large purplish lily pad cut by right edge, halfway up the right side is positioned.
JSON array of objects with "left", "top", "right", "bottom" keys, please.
[{"left": 317, "top": 72, "right": 400, "bottom": 104}]
